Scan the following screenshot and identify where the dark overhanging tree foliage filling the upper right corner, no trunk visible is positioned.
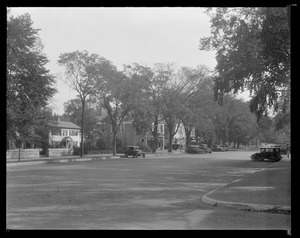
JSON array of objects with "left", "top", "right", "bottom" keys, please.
[{"left": 200, "top": 8, "right": 290, "bottom": 122}]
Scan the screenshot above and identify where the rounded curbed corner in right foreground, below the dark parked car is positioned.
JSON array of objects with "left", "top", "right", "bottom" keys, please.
[{"left": 202, "top": 156, "right": 291, "bottom": 213}]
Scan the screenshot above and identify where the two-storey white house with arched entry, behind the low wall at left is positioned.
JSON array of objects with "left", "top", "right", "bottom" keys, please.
[{"left": 49, "top": 118, "right": 81, "bottom": 148}]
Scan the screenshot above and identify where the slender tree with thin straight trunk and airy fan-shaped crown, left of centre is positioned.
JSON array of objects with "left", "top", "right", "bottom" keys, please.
[{"left": 58, "top": 50, "right": 113, "bottom": 157}]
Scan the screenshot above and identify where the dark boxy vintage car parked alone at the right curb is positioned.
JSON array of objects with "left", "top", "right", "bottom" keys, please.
[{"left": 251, "top": 146, "right": 282, "bottom": 162}]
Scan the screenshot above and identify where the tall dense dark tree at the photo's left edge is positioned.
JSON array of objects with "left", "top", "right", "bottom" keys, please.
[{"left": 6, "top": 12, "right": 56, "bottom": 149}]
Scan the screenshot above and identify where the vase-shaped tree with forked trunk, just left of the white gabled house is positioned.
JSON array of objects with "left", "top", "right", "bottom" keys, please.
[{"left": 160, "top": 65, "right": 206, "bottom": 152}]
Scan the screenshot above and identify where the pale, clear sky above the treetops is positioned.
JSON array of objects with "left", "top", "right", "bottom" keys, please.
[{"left": 11, "top": 7, "right": 247, "bottom": 115}]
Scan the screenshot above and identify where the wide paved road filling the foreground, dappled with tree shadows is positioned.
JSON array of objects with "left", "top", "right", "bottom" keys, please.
[{"left": 7, "top": 152, "right": 291, "bottom": 230}]
